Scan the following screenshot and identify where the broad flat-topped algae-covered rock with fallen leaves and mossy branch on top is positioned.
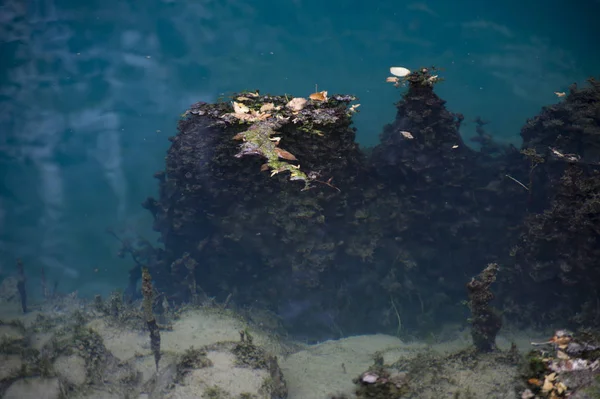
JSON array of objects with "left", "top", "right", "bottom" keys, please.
[{"left": 146, "top": 93, "right": 365, "bottom": 332}]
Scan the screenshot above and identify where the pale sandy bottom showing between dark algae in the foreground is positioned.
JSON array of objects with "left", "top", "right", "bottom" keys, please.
[{"left": 0, "top": 305, "right": 546, "bottom": 399}]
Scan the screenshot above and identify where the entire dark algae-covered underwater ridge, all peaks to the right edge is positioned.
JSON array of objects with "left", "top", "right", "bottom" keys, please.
[{"left": 131, "top": 67, "right": 600, "bottom": 340}]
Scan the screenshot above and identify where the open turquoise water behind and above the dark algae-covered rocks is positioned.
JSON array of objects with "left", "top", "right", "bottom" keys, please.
[{"left": 0, "top": 0, "right": 600, "bottom": 295}]
